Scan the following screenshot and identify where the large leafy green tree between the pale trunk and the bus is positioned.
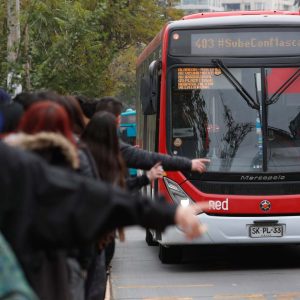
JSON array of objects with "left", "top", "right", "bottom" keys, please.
[{"left": 18, "top": 0, "right": 170, "bottom": 96}]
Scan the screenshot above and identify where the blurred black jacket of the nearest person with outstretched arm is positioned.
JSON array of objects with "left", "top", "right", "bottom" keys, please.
[{"left": 0, "top": 142, "right": 176, "bottom": 298}]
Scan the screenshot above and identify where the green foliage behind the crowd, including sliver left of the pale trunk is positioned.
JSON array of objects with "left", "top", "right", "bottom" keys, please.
[{"left": 0, "top": 0, "right": 181, "bottom": 101}]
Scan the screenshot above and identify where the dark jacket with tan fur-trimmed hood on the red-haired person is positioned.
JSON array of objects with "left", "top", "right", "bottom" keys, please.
[{"left": 5, "top": 132, "right": 79, "bottom": 300}]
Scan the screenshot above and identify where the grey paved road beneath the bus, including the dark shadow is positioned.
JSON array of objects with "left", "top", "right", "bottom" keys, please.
[{"left": 111, "top": 228, "right": 300, "bottom": 300}]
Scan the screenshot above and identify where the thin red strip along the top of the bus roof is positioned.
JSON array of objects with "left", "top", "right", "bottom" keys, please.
[{"left": 182, "top": 10, "right": 300, "bottom": 20}]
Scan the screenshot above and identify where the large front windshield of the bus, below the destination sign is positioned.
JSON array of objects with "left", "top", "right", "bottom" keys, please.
[{"left": 170, "top": 66, "right": 300, "bottom": 173}]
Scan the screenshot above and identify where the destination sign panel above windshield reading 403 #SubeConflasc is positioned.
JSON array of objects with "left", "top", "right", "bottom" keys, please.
[{"left": 170, "top": 29, "right": 300, "bottom": 57}]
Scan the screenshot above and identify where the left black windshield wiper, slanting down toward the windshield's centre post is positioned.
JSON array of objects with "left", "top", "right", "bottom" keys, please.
[{"left": 212, "top": 59, "right": 260, "bottom": 109}]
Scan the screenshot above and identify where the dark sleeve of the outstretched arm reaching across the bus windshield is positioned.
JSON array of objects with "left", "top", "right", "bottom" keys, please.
[{"left": 119, "top": 140, "right": 192, "bottom": 171}]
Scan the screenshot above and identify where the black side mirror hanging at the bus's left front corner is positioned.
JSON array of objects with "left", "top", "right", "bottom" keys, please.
[{"left": 141, "top": 60, "right": 161, "bottom": 115}]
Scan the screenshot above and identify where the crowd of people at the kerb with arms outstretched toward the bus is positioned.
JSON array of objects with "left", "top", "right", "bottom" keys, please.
[{"left": 0, "top": 89, "right": 208, "bottom": 300}]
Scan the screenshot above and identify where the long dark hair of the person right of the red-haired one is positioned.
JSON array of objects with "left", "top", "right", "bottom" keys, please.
[{"left": 81, "top": 111, "right": 126, "bottom": 187}]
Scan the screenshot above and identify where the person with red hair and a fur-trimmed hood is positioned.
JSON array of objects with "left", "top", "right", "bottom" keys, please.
[{"left": 5, "top": 100, "right": 86, "bottom": 300}]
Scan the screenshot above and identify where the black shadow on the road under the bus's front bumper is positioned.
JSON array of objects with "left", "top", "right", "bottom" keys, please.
[{"left": 153, "top": 245, "right": 300, "bottom": 271}]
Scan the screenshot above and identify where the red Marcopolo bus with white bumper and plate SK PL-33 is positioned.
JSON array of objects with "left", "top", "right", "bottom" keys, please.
[{"left": 136, "top": 11, "right": 300, "bottom": 263}]
